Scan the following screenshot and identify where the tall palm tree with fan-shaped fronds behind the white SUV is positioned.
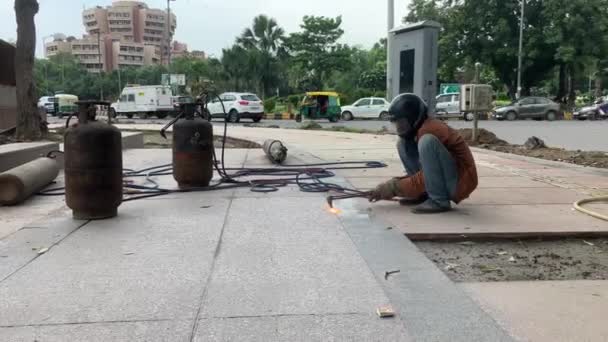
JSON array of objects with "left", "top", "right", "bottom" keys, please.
[{"left": 237, "top": 14, "right": 285, "bottom": 97}]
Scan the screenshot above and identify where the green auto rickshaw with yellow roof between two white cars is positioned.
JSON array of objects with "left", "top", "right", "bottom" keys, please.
[{"left": 296, "top": 91, "right": 341, "bottom": 122}]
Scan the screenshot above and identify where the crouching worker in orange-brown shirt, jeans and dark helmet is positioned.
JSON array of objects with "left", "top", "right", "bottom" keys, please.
[{"left": 370, "top": 94, "right": 477, "bottom": 214}]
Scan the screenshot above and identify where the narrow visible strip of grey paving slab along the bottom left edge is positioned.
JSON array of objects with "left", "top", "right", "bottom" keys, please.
[{"left": 0, "top": 320, "right": 191, "bottom": 342}]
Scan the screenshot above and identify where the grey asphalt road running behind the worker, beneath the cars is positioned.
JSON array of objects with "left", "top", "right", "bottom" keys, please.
[{"left": 49, "top": 118, "right": 608, "bottom": 152}]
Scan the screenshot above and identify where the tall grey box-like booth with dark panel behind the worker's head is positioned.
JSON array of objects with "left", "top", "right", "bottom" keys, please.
[{"left": 387, "top": 20, "right": 441, "bottom": 111}]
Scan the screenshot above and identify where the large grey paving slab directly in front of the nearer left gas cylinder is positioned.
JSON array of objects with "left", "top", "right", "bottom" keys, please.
[{"left": 0, "top": 200, "right": 229, "bottom": 326}]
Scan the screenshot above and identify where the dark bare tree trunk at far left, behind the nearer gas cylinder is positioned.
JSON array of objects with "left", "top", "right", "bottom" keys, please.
[{"left": 15, "top": 0, "right": 41, "bottom": 140}]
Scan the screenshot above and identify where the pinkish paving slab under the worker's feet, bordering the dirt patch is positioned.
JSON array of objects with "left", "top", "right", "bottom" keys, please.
[{"left": 366, "top": 201, "right": 608, "bottom": 239}]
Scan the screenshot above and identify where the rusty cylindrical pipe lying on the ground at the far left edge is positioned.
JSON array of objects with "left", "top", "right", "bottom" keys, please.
[{"left": 0, "top": 157, "right": 59, "bottom": 205}]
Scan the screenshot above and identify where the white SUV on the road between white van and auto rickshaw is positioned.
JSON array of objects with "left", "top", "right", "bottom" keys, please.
[{"left": 207, "top": 93, "right": 264, "bottom": 122}]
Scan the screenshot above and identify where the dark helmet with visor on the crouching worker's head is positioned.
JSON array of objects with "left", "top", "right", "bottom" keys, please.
[{"left": 388, "top": 94, "right": 428, "bottom": 139}]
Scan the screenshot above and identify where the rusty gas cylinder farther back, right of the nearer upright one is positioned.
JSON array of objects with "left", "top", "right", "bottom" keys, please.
[{"left": 173, "top": 103, "right": 213, "bottom": 189}]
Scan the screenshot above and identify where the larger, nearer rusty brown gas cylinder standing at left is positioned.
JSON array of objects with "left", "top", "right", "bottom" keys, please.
[{"left": 64, "top": 101, "right": 122, "bottom": 220}]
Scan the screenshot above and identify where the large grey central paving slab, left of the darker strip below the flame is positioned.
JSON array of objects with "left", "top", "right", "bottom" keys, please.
[{"left": 202, "top": 198, "right": 388, "bottom": 317}]
